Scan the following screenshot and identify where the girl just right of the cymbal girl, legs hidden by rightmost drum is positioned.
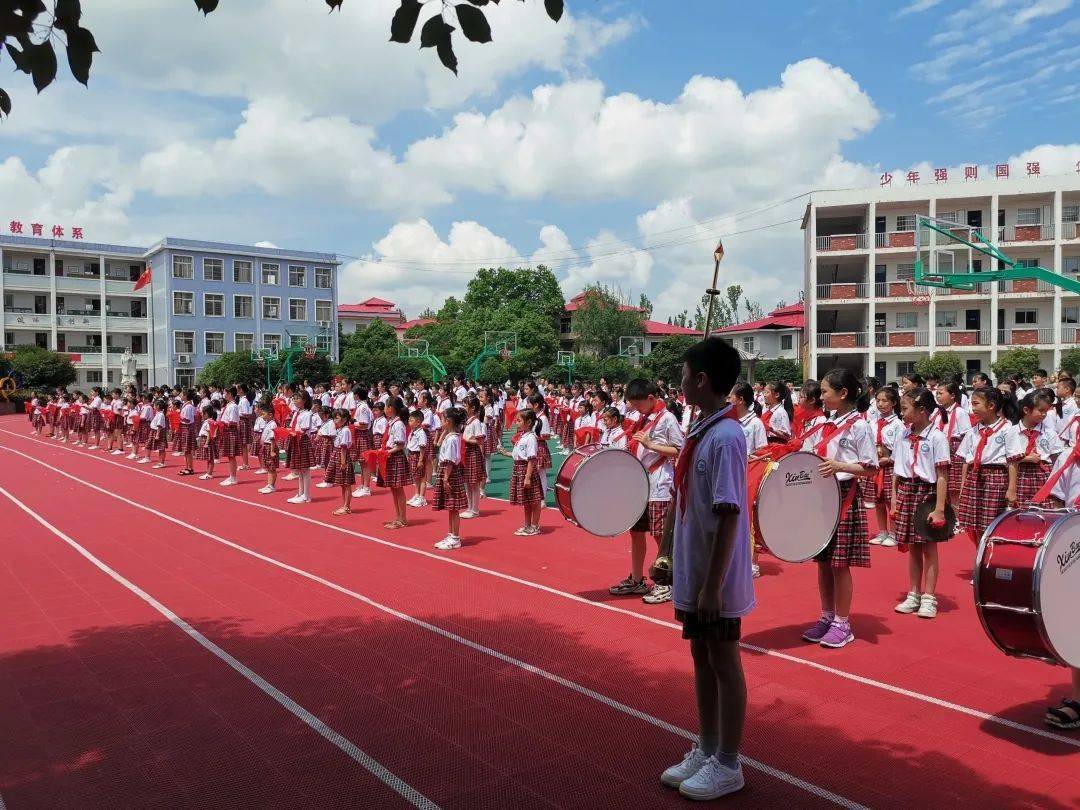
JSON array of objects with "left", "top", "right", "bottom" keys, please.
[{"left": 957, "top": 388, "right": 1016, "bottom": 543}]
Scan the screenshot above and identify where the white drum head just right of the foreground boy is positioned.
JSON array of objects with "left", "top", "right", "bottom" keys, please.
[{"left": 757, "top": 453, "right": 838, "bottom": 563}]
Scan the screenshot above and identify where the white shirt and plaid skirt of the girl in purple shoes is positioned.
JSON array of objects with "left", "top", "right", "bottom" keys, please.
[{"left": 804, "top": 410, "right": 877, "bottom": 568}]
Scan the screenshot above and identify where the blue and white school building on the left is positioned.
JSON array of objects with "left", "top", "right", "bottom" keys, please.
[{"left": 0, "top": 234, "right": 340, "bottom": 389}]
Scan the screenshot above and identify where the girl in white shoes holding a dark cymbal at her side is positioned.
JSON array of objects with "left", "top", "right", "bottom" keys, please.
[{"left": 892, "top": 388, "right": 949, "bottom": 619}]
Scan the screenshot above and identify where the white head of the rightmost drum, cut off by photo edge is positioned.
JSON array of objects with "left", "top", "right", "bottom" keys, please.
[{"left": 1035, "top": 512, "right": 1080, "bottom": 666}]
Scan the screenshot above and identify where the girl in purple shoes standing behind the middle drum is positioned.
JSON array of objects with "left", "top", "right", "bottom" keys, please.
[{"left": 802, "top": 368, "right": 877, "bottom": 648}]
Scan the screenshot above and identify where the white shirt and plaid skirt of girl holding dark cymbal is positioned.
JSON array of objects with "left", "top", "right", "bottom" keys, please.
[{"left": 892, "top": 423, "right": 950, "bottom": 543}]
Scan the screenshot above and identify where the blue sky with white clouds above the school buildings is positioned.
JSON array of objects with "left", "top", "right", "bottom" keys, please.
[{"left": 0, "top": 0, "right": 1080, "bottom": 315}]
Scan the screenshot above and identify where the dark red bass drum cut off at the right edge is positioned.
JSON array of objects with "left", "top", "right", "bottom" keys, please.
[{"left": 975, "top": 509, "right": 1080, "bottom": 667}]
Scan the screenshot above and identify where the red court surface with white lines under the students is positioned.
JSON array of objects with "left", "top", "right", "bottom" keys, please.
[{"left": 0, "top": 417, "right": 1080, "bottom": 808}]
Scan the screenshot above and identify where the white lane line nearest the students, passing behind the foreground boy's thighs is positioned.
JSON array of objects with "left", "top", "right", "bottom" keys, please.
[{"left": 8, "top": 429, "right": 1080, "bottom": 747}]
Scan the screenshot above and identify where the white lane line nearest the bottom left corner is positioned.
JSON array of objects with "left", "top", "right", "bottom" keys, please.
[{"left": 0, "top": 486, "right": 438, "bottom": 810}]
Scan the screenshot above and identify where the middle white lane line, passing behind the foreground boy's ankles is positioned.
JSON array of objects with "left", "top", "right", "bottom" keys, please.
[{"left": 0, "top": 447, "right": 866, "bottom": 810}]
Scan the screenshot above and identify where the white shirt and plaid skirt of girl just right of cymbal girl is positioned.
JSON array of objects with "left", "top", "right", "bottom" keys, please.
[{"left": 957, "top": 419, "right": 1010, "bottom": 541}]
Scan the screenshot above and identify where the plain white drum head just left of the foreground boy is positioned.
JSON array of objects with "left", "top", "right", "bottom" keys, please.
[{"left": 570, "top": 449, "right": 649, "bottom": 537}]
